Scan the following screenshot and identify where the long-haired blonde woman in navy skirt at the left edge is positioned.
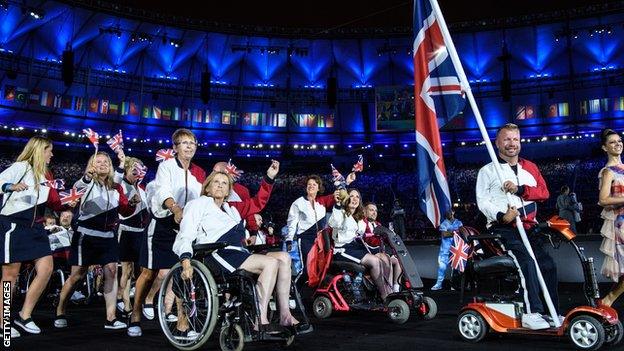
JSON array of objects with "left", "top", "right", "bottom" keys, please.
[{"left": 0, "top": 136, "right": 65, "bottom": 337}]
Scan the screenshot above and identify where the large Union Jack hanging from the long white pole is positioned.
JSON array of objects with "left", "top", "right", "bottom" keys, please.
[{"left": 413, "top": 0, "right": 465, "bottom": 227}]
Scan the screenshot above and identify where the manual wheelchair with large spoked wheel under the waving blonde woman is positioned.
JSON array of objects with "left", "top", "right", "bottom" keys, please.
[{"left": 158, "top": 242, "right": 309, "bottom": 351}]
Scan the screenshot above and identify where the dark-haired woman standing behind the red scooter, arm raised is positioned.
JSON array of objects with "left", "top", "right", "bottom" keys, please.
[{"left": 285, "top": 172, "right": 355, "bottom": 272}]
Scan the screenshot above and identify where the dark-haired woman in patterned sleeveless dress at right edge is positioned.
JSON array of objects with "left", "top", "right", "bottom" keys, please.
[{"left": 598, "top": 129, "right": 624, "bottom": 306}]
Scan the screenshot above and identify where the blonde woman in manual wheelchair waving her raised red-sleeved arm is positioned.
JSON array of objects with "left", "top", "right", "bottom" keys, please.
[{"left": 173, "top": 161, "right": 299, "bottom": 331}]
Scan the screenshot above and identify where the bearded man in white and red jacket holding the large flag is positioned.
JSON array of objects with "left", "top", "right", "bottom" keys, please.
[{"left": 476, "top": 123, "right": 563, "bottom": 329}]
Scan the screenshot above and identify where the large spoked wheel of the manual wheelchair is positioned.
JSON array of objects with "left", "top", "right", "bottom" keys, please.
[{"left": 158, "top": 260, "right": 219, "bottom": 351}]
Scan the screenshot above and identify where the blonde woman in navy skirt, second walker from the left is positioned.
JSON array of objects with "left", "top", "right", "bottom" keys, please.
[{"left": 54, "top": 151, "right": 141, "bottom": 329}]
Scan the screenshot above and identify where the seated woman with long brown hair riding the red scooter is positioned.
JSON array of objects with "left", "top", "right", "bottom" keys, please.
[{"left": 328, "top": 189, "right": 390, "bottom": 300}]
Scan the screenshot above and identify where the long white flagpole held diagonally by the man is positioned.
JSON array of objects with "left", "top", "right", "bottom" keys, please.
[{"left": 429, "top": 0, "right": 561, "bottom": 328}]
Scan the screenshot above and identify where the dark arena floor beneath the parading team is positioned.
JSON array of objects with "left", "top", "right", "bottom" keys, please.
[{"left": 11, "top": 280, "right": 624, "bottom": 351}]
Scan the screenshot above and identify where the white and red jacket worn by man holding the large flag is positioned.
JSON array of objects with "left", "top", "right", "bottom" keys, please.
[{"left": 476, "top": 158, "right": 550, "bottom": 228}]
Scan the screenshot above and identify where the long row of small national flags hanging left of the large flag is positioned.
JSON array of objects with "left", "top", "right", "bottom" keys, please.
[{"left": 4, "top": 85, "right": 334, "bottom": 128}]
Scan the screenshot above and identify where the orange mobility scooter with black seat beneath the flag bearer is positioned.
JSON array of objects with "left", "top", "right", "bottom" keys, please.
[{"left": 452, "top": 216, "right": 623, "bottom": 350}]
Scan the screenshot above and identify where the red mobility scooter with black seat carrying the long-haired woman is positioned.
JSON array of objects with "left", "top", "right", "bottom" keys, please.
[{"left": 306, "top": 226, "right": 437, "bottom": 324}]
